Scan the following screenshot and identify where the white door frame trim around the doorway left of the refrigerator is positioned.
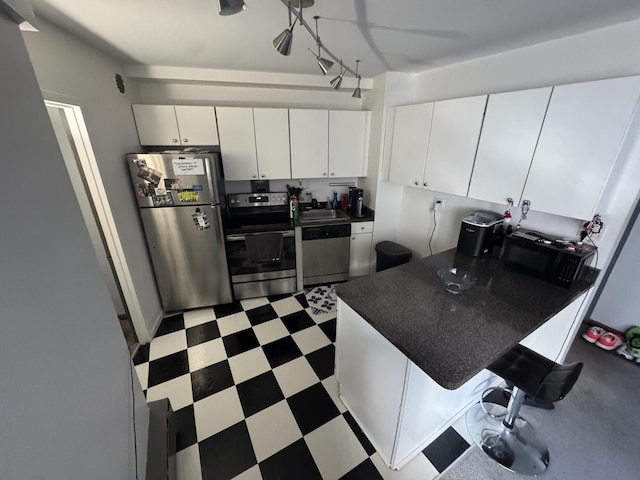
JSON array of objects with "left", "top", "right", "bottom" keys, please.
[{"left": 43, "top": 99, "right": 151, "bottom": 343}]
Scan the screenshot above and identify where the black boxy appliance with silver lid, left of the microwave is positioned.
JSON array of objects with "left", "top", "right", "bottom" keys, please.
[{"left": 458, "top": 211, "right": 503, "bottom": 257}]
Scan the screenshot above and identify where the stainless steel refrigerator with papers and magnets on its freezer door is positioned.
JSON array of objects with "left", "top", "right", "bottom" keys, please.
[{"left": 127, "top": 153, "right": 232, "bottom": 312}]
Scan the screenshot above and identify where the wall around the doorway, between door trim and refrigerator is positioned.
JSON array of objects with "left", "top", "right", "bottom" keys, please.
[{"left": 24, "top": 21, "right": 162, "bottom": 340}]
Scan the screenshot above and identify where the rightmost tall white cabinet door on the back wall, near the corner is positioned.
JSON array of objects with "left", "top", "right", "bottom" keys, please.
[{"left": 329, "top": 110, "right": 369, "bottom": 177}]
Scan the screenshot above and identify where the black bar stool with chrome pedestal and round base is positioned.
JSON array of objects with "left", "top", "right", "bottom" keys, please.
[{"left": 467, "top": 345, "right": 583, "bottom": 475}]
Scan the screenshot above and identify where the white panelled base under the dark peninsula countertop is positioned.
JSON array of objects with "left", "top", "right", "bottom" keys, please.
[{"left": 336, "top": 299, "right": 497, "bottom": 470}]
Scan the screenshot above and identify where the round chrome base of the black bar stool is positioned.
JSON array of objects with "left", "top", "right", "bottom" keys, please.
[{"left": 466, "top": 402, "right": 549, "bottom": 476}]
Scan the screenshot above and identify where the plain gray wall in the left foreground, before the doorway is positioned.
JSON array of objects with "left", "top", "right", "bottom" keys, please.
[{"left": 0, "top": 14, "right": 147, "bottom": 480}]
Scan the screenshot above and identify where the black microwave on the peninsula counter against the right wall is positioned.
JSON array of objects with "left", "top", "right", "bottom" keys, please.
[{"left": 500, "top": 230, "right": 596, "bottom": 288}]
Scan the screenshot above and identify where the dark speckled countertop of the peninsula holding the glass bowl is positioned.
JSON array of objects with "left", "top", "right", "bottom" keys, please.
[{"left": 336, "top": 249, "right": 597, "bottom": 389}]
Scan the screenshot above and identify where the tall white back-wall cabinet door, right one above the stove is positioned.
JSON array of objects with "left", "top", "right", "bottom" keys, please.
[{"left": 253, "top": 108, "right": 291, "bottom": 180}]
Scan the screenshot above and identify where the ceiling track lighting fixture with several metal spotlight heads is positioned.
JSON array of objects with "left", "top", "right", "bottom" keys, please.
[{"left": 218, "top": 0, "right": 362, "bottom": 98}]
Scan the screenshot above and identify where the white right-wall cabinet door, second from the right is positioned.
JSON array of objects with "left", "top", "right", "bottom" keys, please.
[{"left": 468, "top": 87, "right": 551, "bottom": 205}]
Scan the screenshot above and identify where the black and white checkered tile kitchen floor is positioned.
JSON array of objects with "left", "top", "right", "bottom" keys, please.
[{"left": 133, "top": 294, "right": 469, "bottom": 480}]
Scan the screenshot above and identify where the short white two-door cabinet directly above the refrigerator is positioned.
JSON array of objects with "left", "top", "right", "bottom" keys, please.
[{"left": 132, "top": 105, "right": 219, "bottom": 146}]
